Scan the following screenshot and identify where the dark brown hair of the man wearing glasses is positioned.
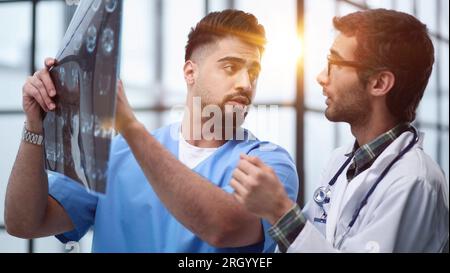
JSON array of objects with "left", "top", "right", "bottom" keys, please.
[{"left": 333, "top": 9, "right": 434, "bottom": 122}]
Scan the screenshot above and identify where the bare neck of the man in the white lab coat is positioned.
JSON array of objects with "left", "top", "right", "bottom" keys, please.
[{"left": 350, "top": 111, "right": 398, "bottom": 147}]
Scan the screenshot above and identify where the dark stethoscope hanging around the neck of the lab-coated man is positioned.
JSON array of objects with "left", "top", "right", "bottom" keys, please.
[{"left": 313, "top": 127, "right": 419, "bottom": 249}]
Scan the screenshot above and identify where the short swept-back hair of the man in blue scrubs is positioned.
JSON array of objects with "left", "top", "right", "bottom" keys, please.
[{"left": 185, "top": 9, "right": 266, "bottom": 61}]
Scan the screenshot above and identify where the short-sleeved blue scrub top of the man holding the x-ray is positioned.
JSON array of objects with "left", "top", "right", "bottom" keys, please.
[{"left": 48, "top": 123, "right": 299, "bottom": 253}]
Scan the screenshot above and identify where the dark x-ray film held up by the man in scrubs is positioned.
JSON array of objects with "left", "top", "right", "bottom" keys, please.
[{"left": 44, "top": 0, "right": 122, "bottom": 193}]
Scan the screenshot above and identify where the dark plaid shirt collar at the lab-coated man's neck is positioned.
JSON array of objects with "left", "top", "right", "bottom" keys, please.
[{"left": 346, "top": 123, "right": 411, "bottom": 181}]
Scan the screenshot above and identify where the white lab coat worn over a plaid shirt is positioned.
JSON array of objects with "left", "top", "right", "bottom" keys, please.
[{"left": 287, "top": 132, "right": 449, "bottom": 252}]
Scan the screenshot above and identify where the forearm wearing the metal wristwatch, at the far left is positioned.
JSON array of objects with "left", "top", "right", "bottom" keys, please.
[{"left": 5, "top": 120, "right": 48, "bottom": 232}]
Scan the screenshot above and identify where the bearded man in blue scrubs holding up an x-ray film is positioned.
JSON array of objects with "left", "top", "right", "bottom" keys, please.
[{"left": 5, "top": 10, "right": 298, "bottom": 252}]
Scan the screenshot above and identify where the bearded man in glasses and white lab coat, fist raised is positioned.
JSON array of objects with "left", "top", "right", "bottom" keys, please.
[{"left": 231, "top": 9, "right": 449, "bottom": 252}]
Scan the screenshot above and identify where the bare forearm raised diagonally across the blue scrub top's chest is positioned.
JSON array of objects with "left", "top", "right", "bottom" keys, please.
[{"left": 123, "top": 123, "right": 262, "bottom": 247}]
